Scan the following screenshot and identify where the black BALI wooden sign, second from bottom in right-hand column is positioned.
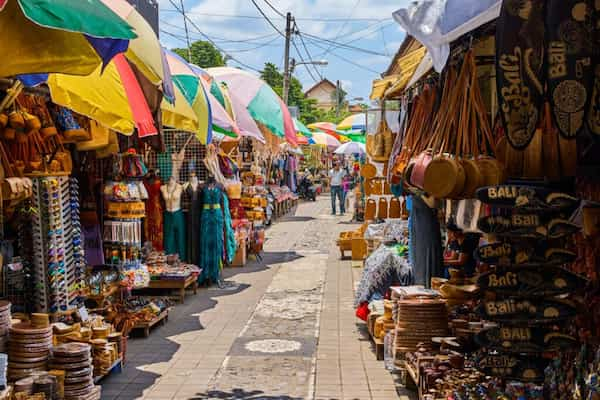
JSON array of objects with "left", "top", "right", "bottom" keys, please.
[{"left": 475, "top": 325, "right": 577, "bottom": 353}]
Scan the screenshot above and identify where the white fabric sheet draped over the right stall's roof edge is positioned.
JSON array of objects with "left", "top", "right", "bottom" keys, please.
[{"left": 393, "top": 0, "right": 502, "bottom": 72}]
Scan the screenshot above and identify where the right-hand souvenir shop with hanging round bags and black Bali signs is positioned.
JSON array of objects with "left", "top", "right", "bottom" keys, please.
[{"left": 346, "top": 1, "right": 600, "bottom": 400}]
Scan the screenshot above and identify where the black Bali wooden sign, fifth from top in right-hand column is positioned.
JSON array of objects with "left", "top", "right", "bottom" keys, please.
[{"left": 477, "top": 298, "right": 576, "bottom": 326}]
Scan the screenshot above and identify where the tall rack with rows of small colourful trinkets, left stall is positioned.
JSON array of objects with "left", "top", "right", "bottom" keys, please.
[{"left": 31, "top": 176, "right": 83, "bottom": 313}]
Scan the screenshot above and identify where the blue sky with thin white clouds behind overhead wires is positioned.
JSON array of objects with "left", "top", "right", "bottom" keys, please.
[{"left": 159, "top": 0, "right": 405, "bottom": 101}]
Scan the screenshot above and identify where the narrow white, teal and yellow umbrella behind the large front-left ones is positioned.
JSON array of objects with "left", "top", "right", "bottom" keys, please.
[{"left": 163, "top": 49, "right": 212, "bottom": 144}]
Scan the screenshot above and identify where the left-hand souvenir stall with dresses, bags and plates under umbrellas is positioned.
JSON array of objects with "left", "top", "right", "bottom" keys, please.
[{"left": 0, "top": 73, "right": 289, "bottom": 399}]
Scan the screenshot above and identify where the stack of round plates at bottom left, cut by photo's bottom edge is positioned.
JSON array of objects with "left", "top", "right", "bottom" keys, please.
[{"left": 50, "top": 343, "right": 99, "bottom": 400}]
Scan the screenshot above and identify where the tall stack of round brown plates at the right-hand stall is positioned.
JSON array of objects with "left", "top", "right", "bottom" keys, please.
[{"left": 396, "top": 298, "right": 448, "bottom": 352}]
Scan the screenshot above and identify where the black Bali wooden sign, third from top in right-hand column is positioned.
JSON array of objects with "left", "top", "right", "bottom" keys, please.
[{"left": 477, "top": 241, "right": 577, "bottom": 266}]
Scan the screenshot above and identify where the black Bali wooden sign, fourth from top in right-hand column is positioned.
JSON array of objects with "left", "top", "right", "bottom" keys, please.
[{"left": 477, "top": 266, "right": 587, "bottom": 297}]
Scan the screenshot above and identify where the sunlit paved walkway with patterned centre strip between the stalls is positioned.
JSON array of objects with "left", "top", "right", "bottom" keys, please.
[{"left": 102, "top": 196, "right": 398, "bottom": 400}]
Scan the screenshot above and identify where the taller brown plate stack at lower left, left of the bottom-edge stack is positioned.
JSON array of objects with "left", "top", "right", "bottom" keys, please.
[{"left": 8, "top": 322, "right": 52, "bottom": 381}]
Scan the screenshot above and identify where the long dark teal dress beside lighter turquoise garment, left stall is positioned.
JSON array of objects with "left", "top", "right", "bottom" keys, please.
[{"left": 198, "top": 186, "right": 225, "bottom": 283}]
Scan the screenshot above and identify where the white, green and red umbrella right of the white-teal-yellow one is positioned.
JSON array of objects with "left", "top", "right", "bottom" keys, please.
[{"left": 207, "top": 67, "right": 297, "bottom": 146}]
